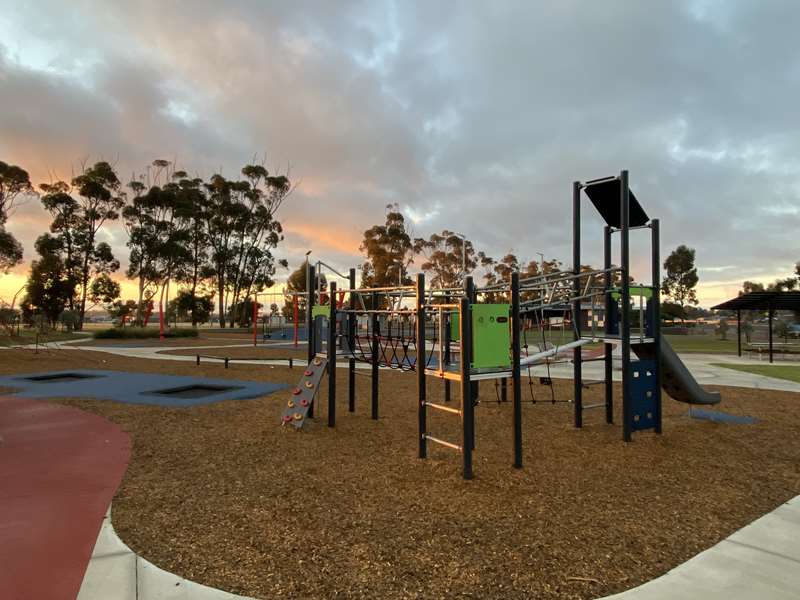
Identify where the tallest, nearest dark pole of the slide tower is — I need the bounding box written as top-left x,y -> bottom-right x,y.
619,171 -> 633,442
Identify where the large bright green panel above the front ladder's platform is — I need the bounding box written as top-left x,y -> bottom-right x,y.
471,304 -> 511,369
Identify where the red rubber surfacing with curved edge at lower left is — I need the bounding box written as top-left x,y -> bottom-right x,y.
0,396 -> 130,600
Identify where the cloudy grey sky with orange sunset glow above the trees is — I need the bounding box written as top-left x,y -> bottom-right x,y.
0,0 -> 800,305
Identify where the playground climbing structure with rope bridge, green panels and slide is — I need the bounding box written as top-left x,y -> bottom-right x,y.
282,171 -> 720,479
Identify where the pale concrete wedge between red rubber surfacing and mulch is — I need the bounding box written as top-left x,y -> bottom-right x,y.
77,508 -> 251,600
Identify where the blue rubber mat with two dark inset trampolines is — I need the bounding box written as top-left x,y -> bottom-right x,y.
0,369 -> 289,407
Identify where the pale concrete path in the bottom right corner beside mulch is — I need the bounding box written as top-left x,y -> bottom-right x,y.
608,496 -> 800,600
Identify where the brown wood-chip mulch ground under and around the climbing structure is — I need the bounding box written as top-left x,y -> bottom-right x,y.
0,351 -> 800,598
